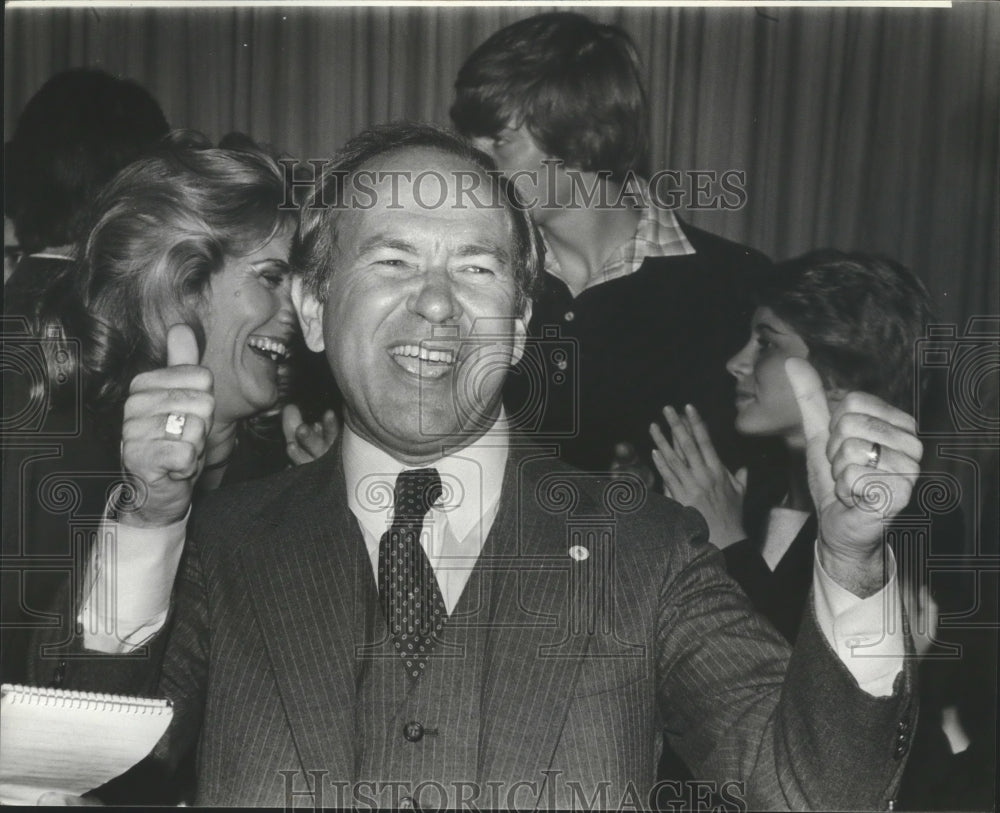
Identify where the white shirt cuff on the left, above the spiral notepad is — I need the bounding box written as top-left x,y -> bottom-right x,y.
77,508 -> 191,654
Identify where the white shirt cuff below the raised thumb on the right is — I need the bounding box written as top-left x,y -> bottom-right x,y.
813,548 -> 906,697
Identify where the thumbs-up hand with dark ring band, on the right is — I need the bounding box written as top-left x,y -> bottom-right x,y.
785,358 -> 923,598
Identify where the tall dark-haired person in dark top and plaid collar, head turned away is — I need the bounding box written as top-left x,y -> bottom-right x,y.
451,12 -> 767,477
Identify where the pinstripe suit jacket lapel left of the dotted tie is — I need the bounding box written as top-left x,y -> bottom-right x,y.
242,444 -> 371,779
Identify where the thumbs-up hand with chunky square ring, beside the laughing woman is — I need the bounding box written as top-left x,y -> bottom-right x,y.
119,325 -> 215,527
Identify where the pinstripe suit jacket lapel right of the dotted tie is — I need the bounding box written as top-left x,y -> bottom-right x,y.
479,449 -> 589,781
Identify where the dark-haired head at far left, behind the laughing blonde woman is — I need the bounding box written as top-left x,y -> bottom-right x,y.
4,68 -> 168,294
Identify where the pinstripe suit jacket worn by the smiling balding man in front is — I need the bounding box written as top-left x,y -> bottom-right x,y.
41,444 -> 916,809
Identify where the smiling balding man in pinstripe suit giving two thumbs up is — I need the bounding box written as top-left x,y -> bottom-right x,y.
36,124 -> 916,809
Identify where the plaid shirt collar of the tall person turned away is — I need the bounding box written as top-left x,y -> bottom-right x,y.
542,179 -> 695,290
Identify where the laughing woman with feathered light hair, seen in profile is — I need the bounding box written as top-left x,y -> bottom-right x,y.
3,134 -> 297,696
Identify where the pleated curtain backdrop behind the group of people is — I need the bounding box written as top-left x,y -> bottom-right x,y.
4,2 -> 1000,323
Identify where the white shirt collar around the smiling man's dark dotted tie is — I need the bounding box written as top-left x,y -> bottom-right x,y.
342,409 -> 510,541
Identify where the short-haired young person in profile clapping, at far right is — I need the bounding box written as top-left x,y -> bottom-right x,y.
650,251 -> 975,810
